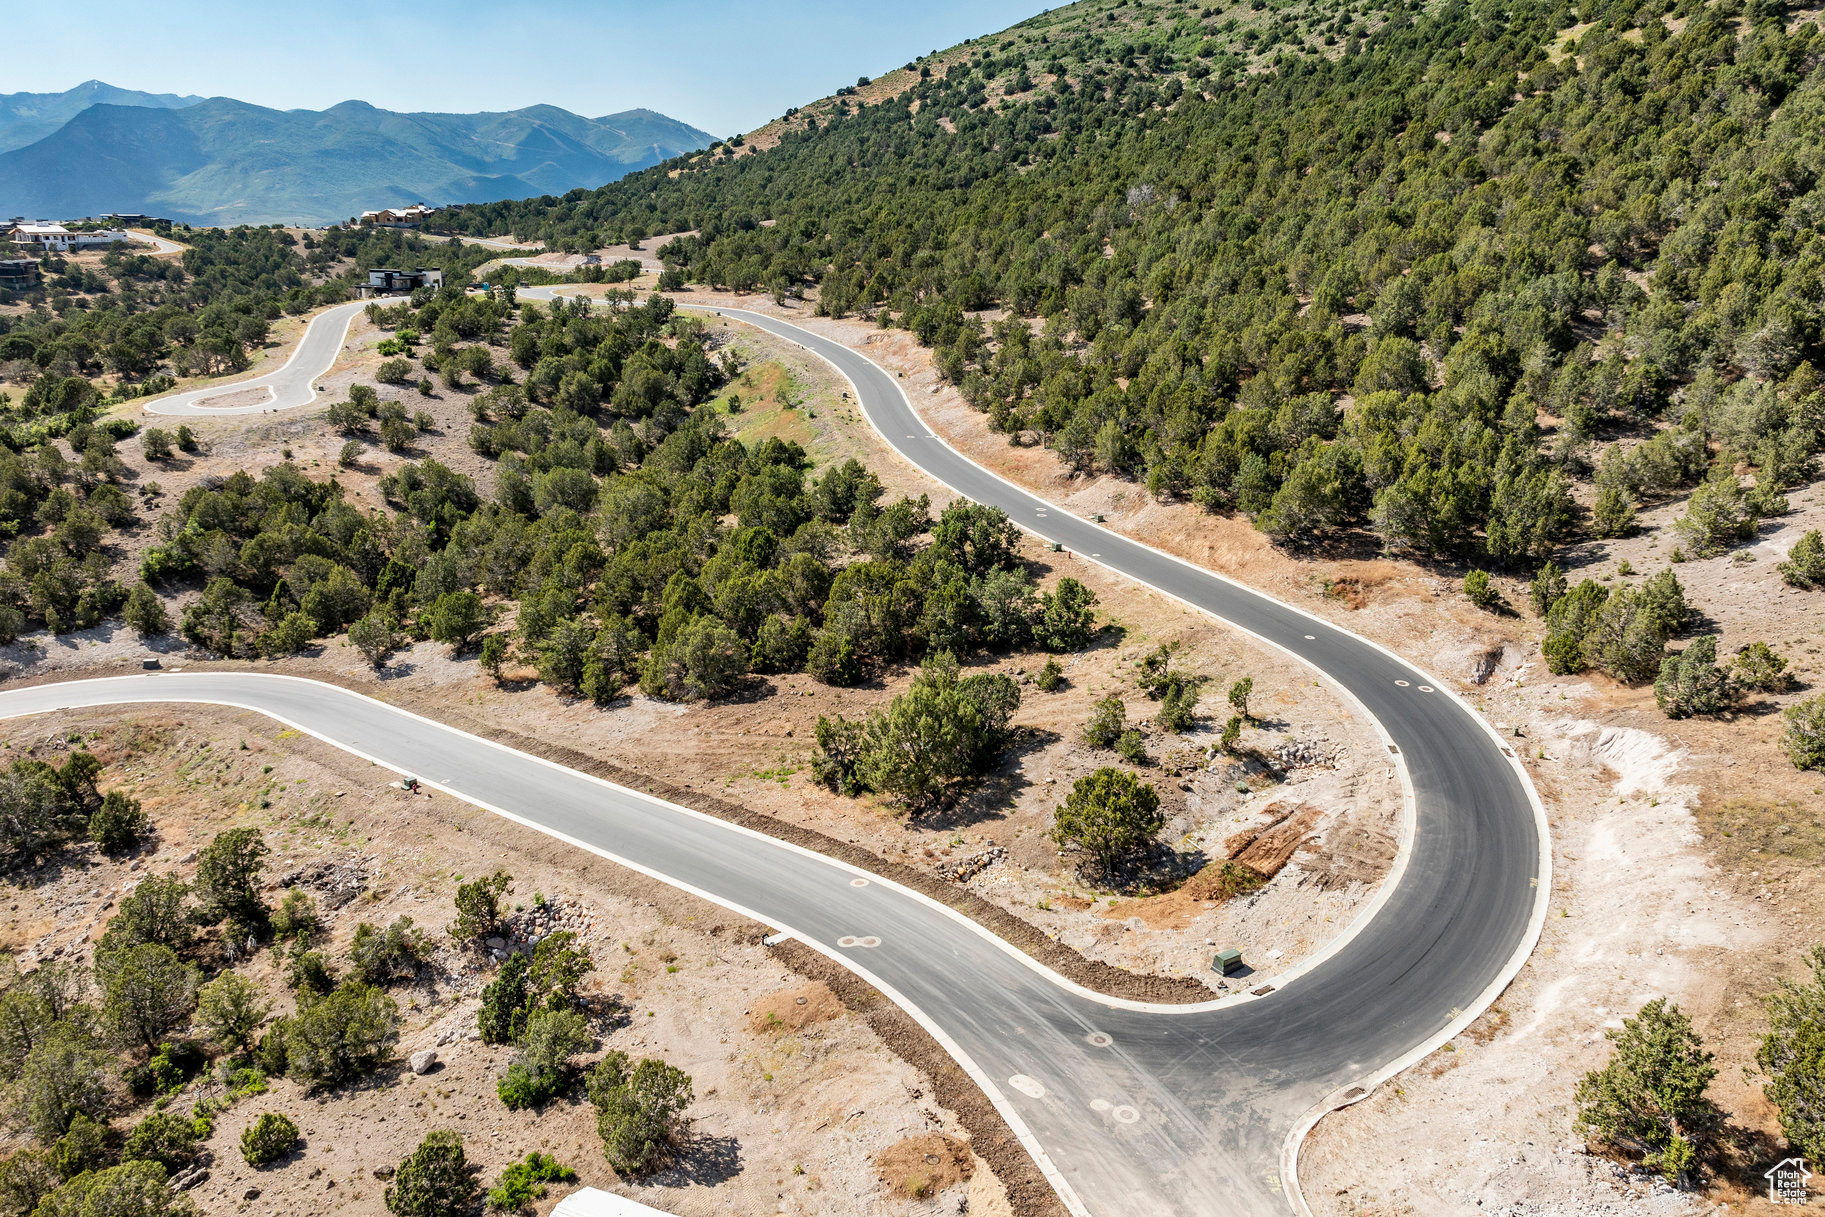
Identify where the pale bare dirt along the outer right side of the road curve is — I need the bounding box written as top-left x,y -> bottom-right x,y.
664,292 -> 1825,1215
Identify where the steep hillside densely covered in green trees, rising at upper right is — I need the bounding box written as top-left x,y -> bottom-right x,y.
441,0 -> 1825,564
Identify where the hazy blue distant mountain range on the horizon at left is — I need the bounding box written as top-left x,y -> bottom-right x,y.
0,80 -> 712,224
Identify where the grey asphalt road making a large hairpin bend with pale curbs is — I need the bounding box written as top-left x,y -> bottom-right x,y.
64,288 -> 1549,1217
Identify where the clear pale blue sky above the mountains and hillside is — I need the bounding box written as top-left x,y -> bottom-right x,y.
0,0 -> 1057,135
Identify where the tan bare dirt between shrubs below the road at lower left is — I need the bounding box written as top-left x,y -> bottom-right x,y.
0,708 -> 1007,1217
